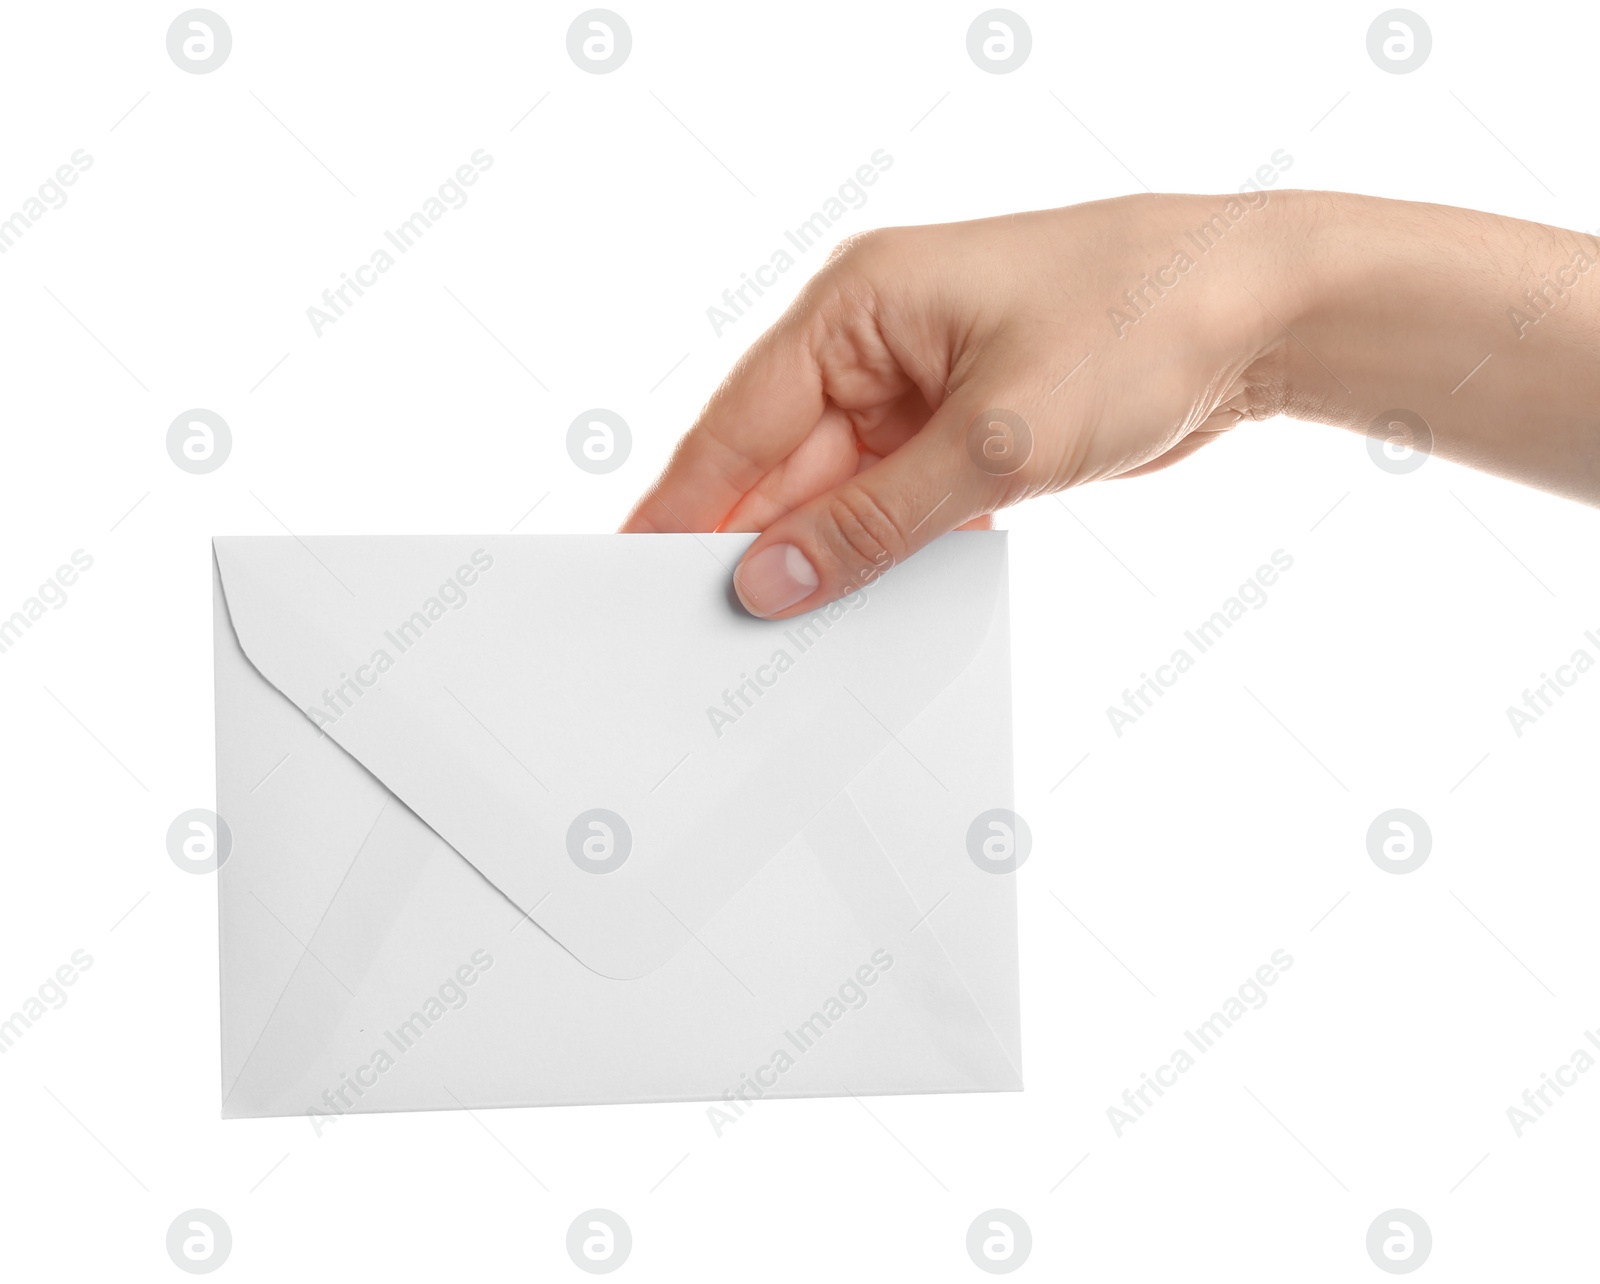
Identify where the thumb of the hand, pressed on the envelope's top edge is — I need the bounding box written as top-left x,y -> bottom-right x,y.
733,394 -> 1032,620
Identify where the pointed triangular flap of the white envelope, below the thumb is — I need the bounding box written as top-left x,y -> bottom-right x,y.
214,532 -> 1005,978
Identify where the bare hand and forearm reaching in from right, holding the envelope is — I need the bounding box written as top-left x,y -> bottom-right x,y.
622,192 -> 1600,620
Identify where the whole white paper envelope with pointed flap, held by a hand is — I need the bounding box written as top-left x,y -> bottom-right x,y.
213,532 -> 1022,1114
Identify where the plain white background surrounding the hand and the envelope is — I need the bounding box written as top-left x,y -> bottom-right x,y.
0,0 -> 1600,1281
